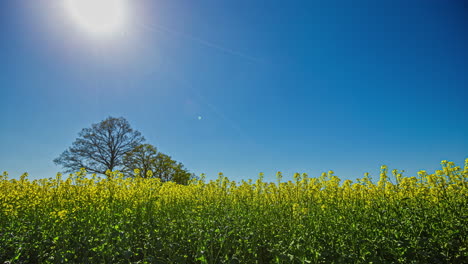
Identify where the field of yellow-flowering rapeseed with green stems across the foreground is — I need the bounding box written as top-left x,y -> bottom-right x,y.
0,160 -> 468,263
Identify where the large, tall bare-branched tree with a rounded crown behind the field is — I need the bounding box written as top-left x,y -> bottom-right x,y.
54,117 -> 145,174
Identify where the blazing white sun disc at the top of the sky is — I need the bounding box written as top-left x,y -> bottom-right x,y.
65,0 -> 128,36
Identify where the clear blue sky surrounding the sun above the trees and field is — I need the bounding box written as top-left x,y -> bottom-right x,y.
0,0 -> 468,180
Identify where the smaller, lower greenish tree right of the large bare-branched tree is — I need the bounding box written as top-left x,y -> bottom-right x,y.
123,144 -> 194,184
